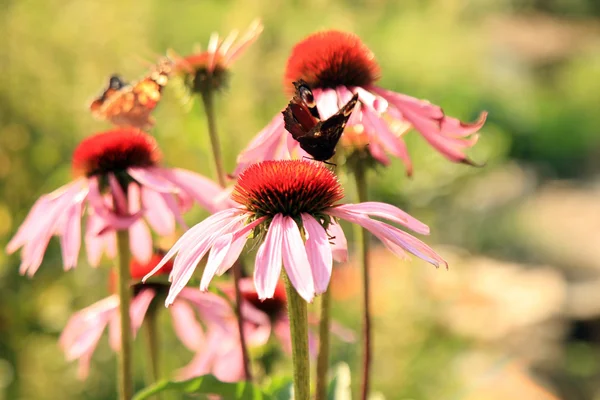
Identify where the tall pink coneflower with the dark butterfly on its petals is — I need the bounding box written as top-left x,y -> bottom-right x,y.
236,31 -> 487,175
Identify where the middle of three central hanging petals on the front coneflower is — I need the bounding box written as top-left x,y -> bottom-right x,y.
281,216 -> 316,303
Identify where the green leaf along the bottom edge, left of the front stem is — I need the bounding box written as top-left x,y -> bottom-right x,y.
133,375 -> 273,400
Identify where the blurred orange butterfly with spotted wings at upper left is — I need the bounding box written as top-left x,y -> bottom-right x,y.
90,58 -> 173,129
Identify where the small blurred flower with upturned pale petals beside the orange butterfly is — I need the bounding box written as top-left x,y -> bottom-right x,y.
170,20 -> 263,93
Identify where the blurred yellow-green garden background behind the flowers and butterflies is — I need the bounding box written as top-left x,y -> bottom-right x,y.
0,0 -> 600,400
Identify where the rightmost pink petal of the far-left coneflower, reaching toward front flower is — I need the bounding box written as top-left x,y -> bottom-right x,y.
155,168 -> 222,213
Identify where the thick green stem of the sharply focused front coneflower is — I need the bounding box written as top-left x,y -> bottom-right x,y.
283,273 -> 310,400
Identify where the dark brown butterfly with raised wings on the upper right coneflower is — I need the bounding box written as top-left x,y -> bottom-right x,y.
283,80 -> 358,162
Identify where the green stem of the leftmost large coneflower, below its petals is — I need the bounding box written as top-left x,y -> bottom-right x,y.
117,230 -> 133,400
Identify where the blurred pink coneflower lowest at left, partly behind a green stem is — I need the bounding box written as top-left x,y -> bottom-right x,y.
59,255 -> 239,380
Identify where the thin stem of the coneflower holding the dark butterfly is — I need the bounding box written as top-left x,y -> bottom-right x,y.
354,163 -> 373,400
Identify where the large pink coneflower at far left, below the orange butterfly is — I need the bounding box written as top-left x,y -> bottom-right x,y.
7,128 -> 221,276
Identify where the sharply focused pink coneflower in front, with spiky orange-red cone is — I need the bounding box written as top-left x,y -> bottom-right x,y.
144,160 -> 445,306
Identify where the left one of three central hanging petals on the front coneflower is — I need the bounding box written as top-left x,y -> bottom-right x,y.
254,214 -> 283,300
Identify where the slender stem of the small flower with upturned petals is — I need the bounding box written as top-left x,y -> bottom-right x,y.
201,89 -> 252,381
